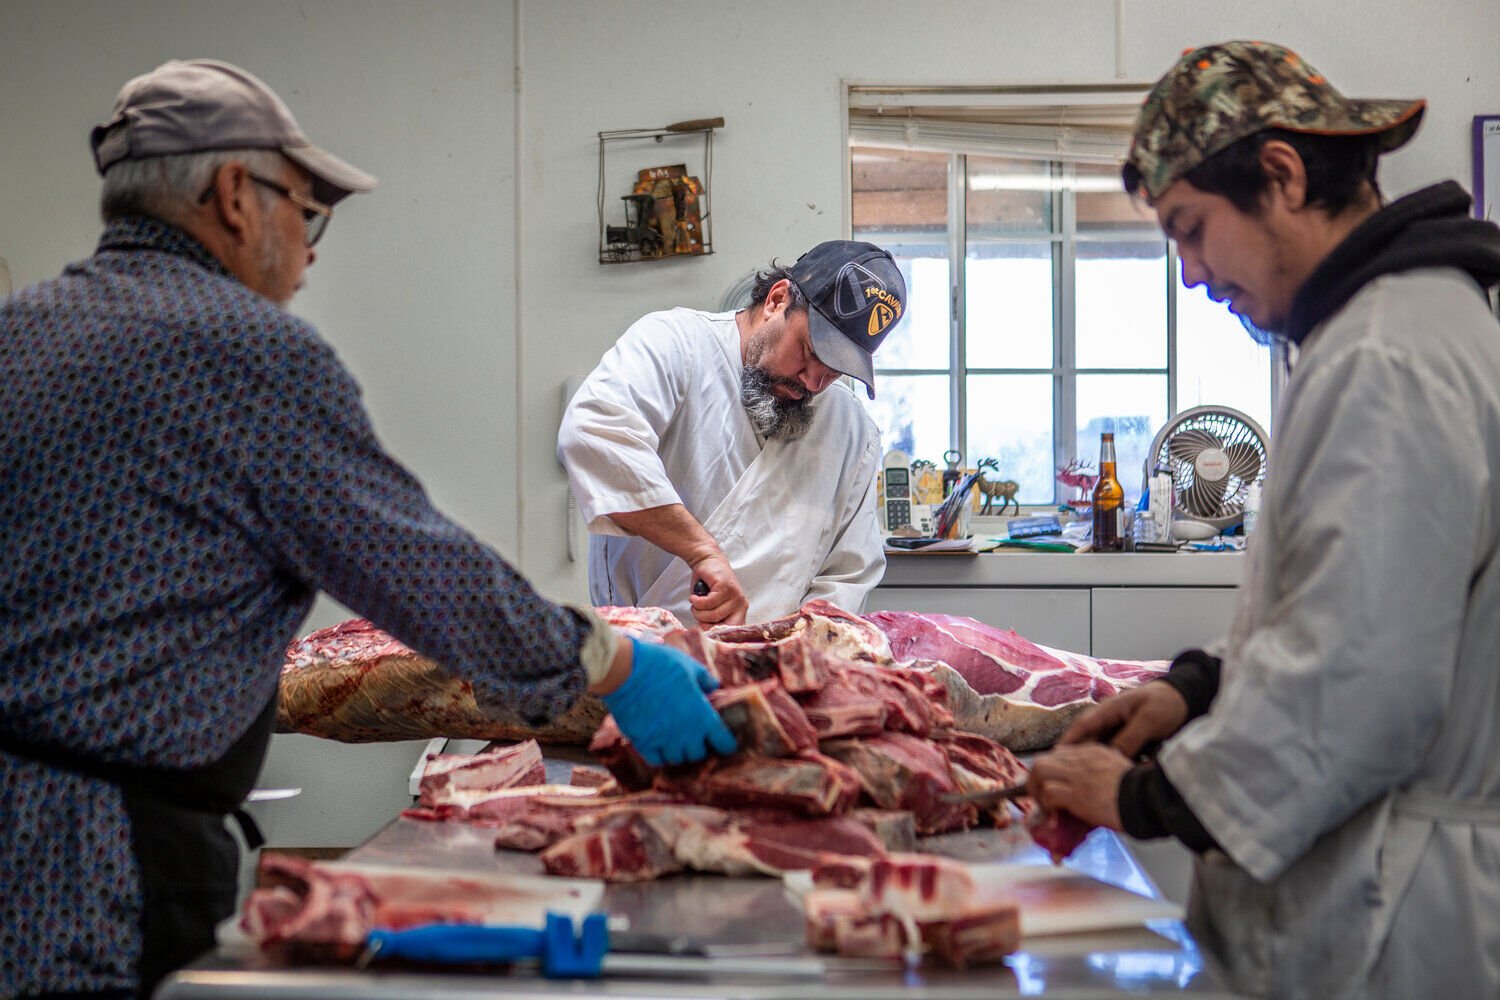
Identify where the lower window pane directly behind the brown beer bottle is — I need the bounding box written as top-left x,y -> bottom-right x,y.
1077,375 -> 1167,502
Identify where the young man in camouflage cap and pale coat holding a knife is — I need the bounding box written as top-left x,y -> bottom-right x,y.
1034,42 -> 1500,999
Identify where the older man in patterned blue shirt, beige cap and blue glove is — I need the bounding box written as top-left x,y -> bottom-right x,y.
0,60 -> 734,997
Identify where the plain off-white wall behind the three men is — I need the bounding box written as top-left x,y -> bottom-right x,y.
0,0 -> 1500,844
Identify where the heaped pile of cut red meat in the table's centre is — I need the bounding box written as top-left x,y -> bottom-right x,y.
410,604 -> 1092,882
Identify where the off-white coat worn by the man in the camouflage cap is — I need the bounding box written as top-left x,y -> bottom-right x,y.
1160,268 -> 1500,1000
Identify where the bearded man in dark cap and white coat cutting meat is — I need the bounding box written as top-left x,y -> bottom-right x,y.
558,240 -> 906,625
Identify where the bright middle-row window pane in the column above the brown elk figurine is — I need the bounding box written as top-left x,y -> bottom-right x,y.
963,241 -> 1053,370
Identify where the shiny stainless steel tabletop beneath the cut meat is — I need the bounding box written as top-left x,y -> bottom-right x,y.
156,762 -> 1233,1000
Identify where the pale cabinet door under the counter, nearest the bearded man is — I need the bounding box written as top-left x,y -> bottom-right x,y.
866,586 -> 1089,652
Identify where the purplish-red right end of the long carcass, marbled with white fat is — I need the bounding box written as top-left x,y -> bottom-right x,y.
867,612 -> 1170,751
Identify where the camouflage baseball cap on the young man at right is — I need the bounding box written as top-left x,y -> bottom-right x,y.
1125,42 -> 1427,201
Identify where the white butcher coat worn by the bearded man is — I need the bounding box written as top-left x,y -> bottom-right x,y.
558,309 -> 885,624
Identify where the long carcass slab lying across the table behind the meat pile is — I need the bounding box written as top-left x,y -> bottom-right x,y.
278,601 -> 1167,751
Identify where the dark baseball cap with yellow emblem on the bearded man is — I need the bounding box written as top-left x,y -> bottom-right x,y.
791,240 -> 906,399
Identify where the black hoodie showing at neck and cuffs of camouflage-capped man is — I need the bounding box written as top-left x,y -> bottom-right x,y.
1119,180 -> 1500,852
